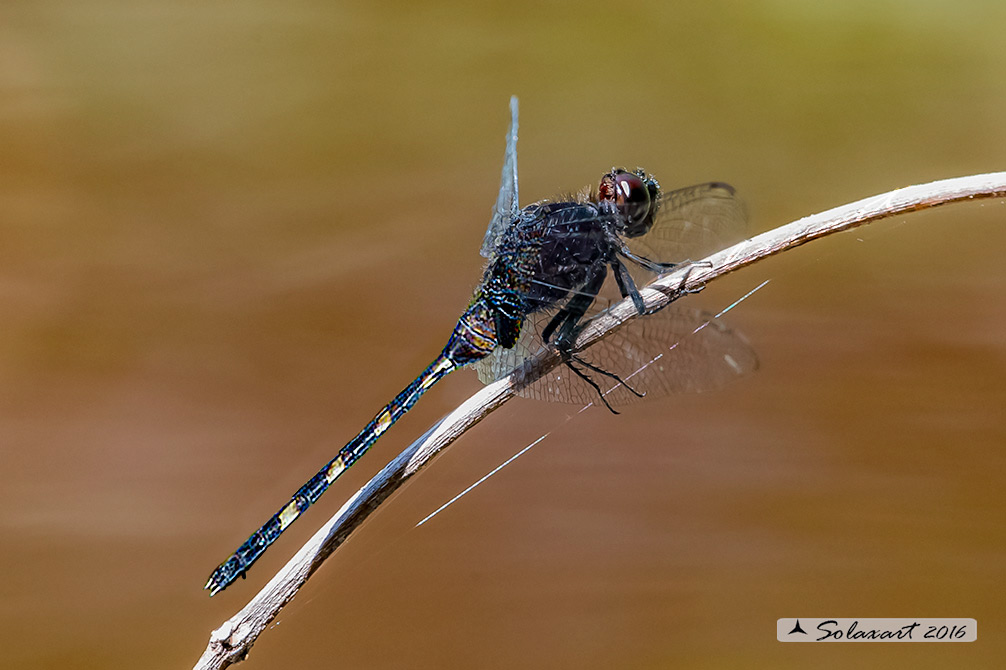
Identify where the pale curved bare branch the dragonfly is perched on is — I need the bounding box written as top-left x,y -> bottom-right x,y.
195,172 -> 1006,669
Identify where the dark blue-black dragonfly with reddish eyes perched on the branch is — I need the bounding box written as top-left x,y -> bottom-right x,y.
205,97 -> 758,596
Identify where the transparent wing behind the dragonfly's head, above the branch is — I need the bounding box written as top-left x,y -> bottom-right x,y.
626,181 -> 747,269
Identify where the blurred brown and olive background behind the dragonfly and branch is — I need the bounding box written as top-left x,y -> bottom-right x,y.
0,0 -> 1006,669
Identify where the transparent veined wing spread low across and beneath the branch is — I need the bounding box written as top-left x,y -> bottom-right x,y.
478,305 -> 758,406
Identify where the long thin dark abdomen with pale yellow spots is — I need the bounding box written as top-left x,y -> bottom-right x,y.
204,350 -> 459,596
